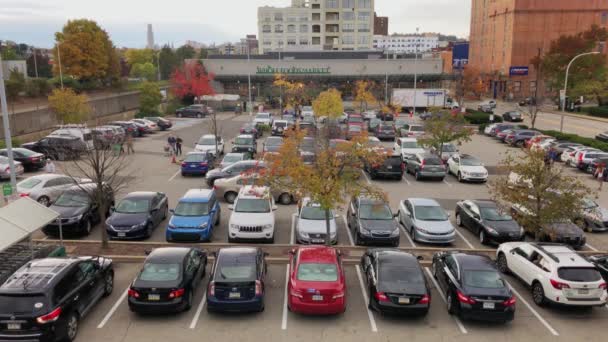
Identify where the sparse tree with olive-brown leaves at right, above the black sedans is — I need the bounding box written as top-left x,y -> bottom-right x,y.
490,150 -> 594,239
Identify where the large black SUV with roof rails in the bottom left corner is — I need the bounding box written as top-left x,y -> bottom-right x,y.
0,257 -> 114,342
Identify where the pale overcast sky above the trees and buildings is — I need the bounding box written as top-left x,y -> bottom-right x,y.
0,0 -> 471,47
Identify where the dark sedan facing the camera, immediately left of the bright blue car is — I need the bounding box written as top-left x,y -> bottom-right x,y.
106,191 -> 169,240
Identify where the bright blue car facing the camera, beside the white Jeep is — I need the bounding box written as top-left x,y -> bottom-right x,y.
166,189 -> 221,242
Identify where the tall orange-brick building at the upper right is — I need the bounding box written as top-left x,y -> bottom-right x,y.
469,0 -> 608,98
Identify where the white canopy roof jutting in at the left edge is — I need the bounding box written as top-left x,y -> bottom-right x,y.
0,197 -> 59,251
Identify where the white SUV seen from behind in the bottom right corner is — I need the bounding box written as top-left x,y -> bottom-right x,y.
496,242 -> 607,306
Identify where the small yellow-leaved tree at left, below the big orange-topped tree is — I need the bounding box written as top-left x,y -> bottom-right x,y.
48,88 -> 91,124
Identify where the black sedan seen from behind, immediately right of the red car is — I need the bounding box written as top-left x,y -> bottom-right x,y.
361,248 -> 431,316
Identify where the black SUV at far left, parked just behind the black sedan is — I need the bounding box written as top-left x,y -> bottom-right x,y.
21,136 -> 87,160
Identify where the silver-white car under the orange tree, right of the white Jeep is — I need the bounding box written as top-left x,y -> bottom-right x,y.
295,197 -> 338,245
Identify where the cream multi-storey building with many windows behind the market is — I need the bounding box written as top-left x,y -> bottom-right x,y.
258,0 -> 375,53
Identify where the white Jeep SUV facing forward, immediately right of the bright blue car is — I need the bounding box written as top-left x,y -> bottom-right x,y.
228,185 -> 277,243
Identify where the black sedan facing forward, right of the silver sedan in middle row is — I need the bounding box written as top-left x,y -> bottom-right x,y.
454,200 -> 525,245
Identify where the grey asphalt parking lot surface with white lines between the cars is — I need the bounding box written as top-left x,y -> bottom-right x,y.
14,114 -> 608,341
